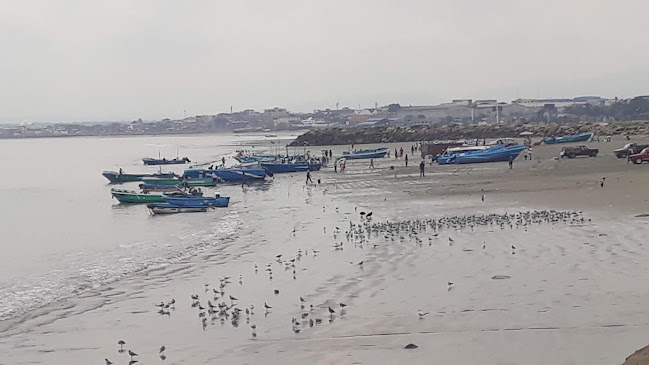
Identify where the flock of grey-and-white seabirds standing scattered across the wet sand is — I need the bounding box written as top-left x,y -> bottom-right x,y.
105,210 -> 590,365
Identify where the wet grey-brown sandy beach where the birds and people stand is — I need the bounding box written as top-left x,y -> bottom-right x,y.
0,135 -> 649,364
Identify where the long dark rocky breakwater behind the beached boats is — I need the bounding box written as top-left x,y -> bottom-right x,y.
291,122 -> 649,146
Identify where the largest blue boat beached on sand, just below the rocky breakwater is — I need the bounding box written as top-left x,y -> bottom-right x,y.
437,145 -> 525,165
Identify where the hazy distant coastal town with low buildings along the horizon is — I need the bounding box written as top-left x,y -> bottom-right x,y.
5,96 -> 649,139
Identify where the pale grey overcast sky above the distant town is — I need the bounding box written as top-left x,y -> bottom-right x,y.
0,0 -> 649,122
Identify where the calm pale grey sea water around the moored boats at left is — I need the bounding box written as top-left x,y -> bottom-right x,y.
0,135 -> 298,319
